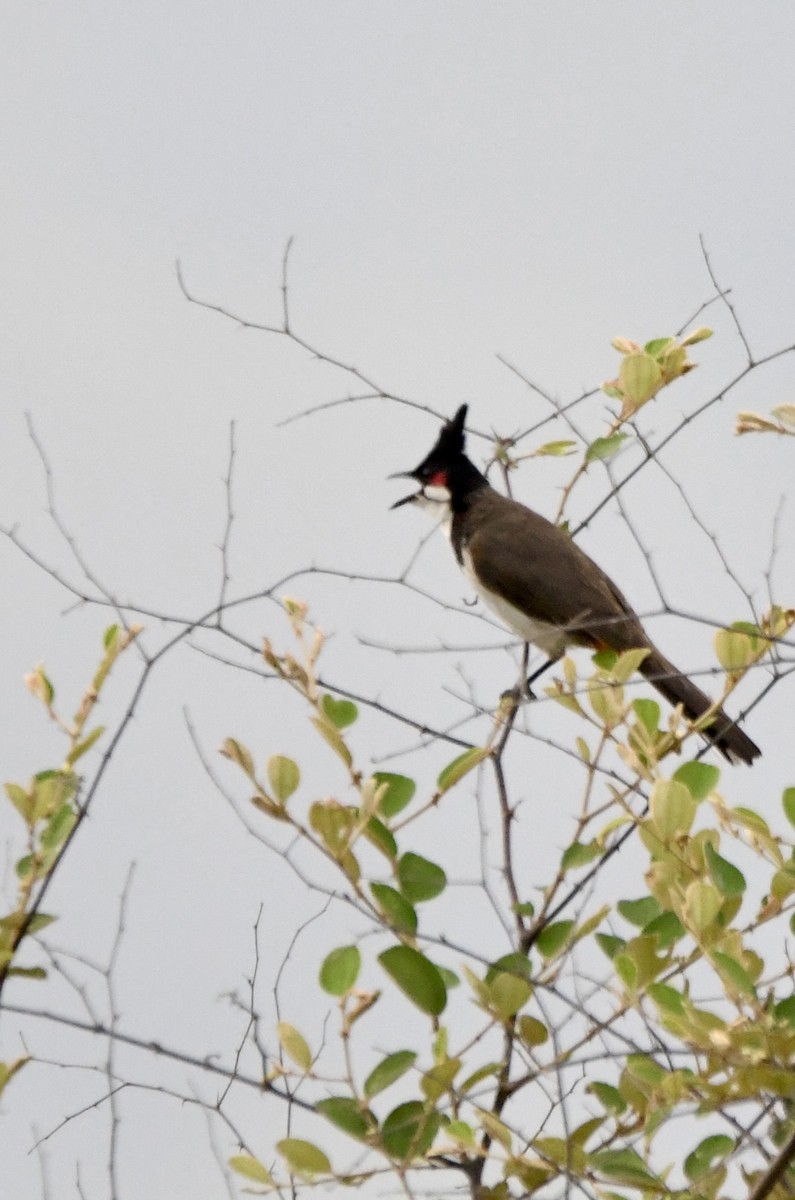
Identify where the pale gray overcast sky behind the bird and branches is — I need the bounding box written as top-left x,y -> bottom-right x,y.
0,0 -> 795,1200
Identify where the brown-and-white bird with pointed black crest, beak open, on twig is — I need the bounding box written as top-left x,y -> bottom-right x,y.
390,404 -> 761,764
